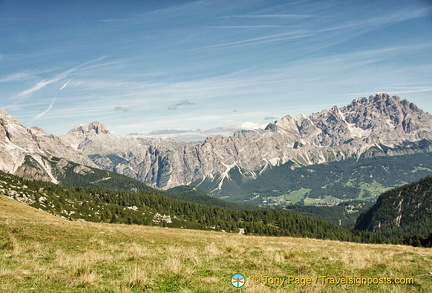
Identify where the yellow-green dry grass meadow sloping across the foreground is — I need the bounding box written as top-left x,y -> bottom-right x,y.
0,195 -> 432,293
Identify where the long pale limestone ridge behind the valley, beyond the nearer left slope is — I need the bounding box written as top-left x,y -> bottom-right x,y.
62,93 -> 432,188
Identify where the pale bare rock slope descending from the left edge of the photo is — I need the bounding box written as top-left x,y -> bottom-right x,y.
0,109 -> 95,183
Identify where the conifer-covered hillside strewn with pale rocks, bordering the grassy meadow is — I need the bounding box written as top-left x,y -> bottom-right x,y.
0,173 -> 360,241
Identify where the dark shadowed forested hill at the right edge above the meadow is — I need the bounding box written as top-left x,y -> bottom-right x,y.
355,176 -> 432,237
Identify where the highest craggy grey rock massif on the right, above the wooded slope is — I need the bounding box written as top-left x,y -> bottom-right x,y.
258,93 -> 432,147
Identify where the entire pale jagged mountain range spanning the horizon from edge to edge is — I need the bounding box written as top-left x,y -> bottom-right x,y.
0,93 -> 432,204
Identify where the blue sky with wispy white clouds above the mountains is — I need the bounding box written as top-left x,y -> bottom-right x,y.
0,0 -> 432,139
